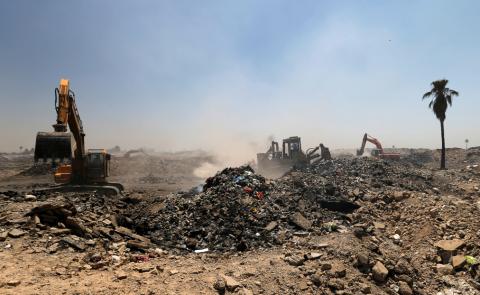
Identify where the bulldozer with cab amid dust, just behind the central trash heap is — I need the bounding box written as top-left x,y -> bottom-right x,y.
257,136 -> 320,174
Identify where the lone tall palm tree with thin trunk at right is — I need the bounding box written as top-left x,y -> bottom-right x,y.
422,79 -> 458,169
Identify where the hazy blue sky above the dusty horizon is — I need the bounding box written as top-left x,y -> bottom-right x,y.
0,0 -> 480,163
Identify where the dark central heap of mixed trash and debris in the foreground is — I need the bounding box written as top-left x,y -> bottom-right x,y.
126,166 -> 358,252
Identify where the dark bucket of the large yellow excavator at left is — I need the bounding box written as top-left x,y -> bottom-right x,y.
34,132 -> 74,162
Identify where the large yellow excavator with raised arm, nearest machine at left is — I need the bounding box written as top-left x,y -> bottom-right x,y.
34,79 -> 123,194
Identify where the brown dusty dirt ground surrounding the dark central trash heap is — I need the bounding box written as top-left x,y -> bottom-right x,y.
0,149 -> 480,295
